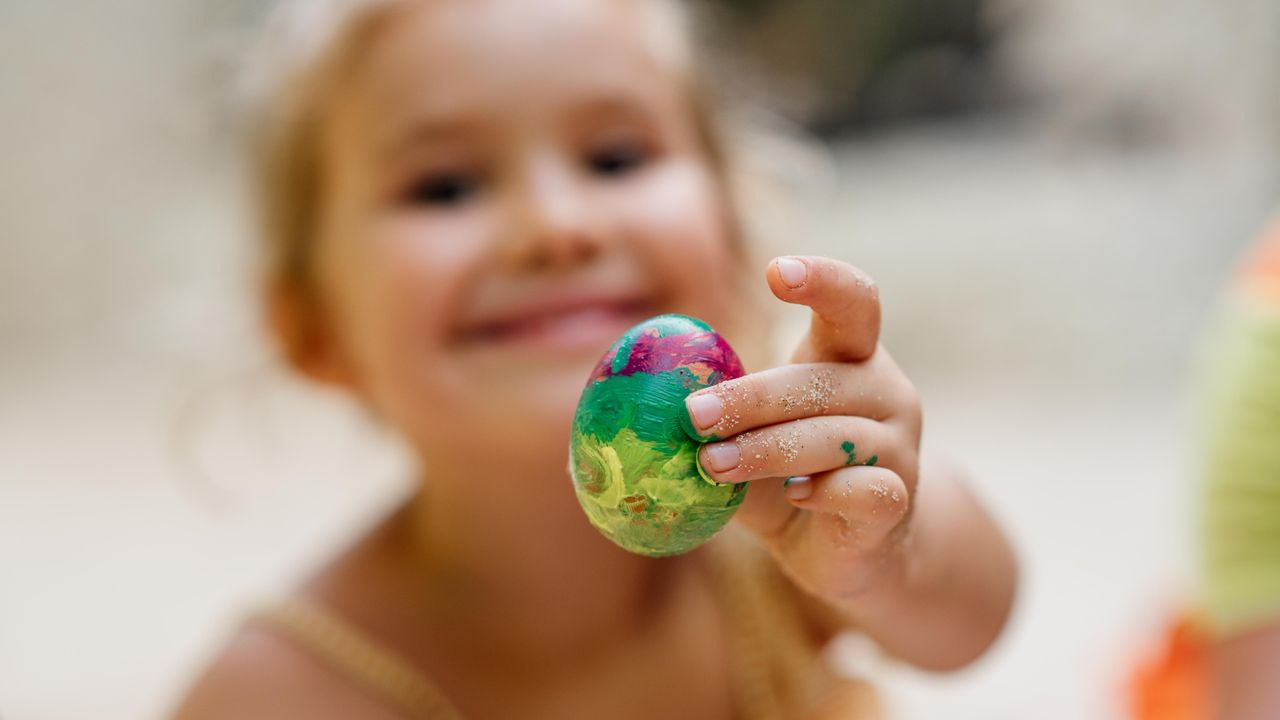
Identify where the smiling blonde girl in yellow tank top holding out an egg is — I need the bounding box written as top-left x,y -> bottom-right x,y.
178,0 -> 1015,719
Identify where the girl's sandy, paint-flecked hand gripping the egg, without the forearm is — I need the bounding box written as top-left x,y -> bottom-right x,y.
686,256 -> 920,605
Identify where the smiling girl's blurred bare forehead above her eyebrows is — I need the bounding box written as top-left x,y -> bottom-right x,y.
356,0 -> 682,132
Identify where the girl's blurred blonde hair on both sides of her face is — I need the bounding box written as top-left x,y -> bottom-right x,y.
246,0 -> 768,366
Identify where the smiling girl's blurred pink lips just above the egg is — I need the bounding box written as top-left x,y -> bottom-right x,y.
460,300 -> 654,351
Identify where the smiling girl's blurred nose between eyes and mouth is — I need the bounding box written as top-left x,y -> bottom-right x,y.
504,158 -> 603,270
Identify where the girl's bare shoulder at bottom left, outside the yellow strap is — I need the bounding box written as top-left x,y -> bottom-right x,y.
174,624 -> 393,720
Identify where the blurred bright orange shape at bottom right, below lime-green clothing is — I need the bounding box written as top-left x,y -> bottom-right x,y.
1129,609 -> 1211,720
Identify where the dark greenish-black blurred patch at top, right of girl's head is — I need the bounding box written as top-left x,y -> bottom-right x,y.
713,0 -> 1004,135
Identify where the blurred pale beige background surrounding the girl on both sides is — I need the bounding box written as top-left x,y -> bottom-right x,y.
0,0 -> 1280,719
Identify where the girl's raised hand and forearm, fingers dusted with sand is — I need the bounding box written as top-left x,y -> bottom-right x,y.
686,258 -> 1016,670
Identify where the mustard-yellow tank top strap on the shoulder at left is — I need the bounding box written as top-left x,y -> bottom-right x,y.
248,598 -> 462,720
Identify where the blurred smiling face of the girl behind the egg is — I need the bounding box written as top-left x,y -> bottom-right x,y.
303,0 -> 733,455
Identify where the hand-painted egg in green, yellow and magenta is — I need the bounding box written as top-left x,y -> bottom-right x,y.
570,315 -> 746,556
